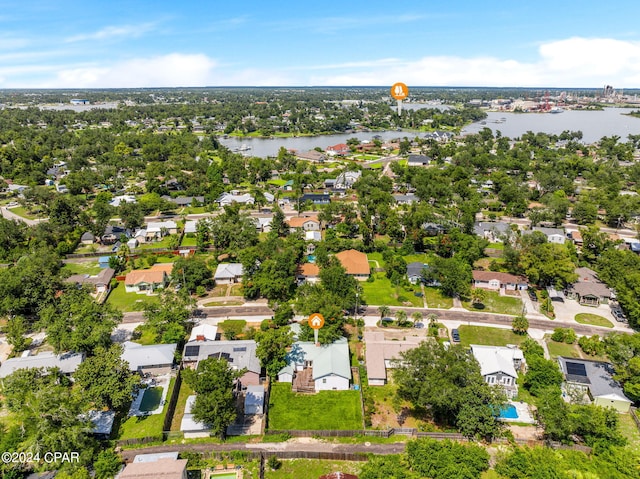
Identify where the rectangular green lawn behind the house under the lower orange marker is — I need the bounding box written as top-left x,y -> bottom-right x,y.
269,383 -> 362,430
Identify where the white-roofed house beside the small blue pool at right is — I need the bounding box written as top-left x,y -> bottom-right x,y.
471,344 -> 525,399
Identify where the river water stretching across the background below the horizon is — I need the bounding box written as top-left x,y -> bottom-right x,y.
220,104 -> 640,158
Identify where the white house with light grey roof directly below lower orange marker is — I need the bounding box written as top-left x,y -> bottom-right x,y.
278,338 -> 351,392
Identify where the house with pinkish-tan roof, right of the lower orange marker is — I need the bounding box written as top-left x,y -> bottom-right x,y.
364,331 -> 425,386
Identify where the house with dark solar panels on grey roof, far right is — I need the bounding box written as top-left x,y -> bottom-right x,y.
557,356 -> 632,413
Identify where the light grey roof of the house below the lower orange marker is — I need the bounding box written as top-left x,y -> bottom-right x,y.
280,338 -> 351,380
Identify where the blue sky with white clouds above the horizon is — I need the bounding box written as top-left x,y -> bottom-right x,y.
0,0 -> 640,88
